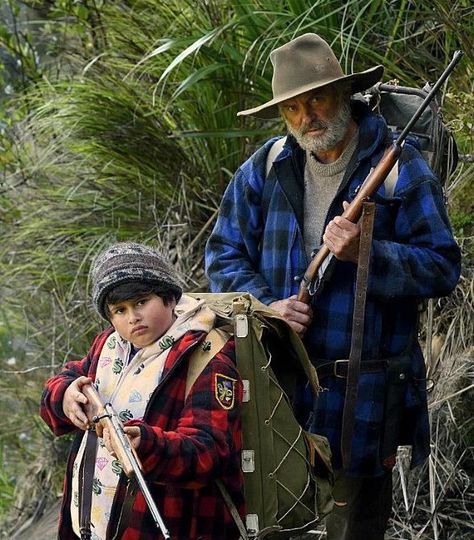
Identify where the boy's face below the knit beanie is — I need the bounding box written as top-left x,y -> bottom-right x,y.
107,293 -> 176,349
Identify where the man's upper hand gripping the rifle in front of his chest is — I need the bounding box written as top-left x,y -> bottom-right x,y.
323,201 -> 360,264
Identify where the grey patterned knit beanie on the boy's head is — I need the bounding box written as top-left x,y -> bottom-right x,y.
90,242 -> 183,320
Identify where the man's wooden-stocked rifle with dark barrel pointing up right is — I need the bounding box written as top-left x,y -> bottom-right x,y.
298,51 -> 463,304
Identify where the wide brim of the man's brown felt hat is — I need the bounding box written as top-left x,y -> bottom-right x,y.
237,66 -> 384,120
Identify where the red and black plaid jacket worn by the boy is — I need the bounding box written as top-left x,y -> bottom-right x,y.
40,329 -> 244,540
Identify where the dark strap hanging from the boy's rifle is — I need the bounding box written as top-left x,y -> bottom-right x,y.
79,429 -> 97,540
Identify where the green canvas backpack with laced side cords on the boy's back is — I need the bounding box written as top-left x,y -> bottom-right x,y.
187,293 -> 333,540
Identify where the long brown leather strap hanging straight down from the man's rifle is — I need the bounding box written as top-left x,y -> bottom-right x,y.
341,201 -> 375,470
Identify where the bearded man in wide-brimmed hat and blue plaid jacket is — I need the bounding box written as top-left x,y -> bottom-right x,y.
206,34 -> 460,540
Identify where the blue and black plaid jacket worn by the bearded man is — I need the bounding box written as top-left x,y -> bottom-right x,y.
206,103 -> 460,476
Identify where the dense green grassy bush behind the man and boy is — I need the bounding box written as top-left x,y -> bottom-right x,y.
0,0 -> 474,538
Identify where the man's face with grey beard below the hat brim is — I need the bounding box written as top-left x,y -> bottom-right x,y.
279,85 -> 351,153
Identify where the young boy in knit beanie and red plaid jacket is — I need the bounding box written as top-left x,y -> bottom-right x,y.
41,243 -> 243,540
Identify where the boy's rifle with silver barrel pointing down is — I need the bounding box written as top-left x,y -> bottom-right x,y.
82,384 -> 171,540
